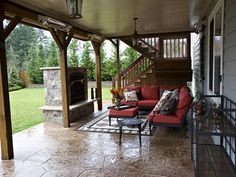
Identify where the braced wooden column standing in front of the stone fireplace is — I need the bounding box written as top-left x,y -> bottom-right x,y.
49,28 -> 72,128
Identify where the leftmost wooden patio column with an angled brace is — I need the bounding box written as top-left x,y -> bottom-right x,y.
0,0 -> 21,160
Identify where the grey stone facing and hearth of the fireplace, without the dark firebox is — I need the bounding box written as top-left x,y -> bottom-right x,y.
40,67 -> 96,125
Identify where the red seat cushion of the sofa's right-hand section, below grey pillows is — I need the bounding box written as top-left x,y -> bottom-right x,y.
147,111 -> 181,125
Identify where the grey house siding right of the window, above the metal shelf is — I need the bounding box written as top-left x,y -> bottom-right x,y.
223,0 -> 236,102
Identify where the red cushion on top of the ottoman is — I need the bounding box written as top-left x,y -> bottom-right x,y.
109,107 -> 139,117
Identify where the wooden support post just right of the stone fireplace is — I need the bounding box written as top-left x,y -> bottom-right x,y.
91,41 -> 102,110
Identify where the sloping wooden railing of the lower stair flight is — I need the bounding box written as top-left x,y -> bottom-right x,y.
112,55 -> 153,88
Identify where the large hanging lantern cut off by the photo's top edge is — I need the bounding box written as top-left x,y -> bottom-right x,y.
66,0 -> 83,19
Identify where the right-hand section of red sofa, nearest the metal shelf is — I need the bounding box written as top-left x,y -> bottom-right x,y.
147,87 -> 193,133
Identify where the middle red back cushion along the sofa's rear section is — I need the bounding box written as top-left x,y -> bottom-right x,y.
141,85 -> 160,100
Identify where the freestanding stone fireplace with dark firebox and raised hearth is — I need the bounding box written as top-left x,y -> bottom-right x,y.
40,67 -> 96,125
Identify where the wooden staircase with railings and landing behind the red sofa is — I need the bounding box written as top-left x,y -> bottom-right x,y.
113,32 -> 192,87
